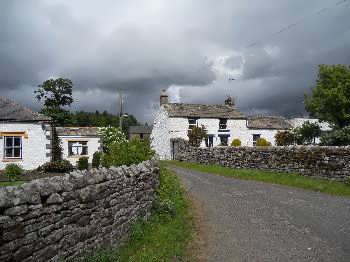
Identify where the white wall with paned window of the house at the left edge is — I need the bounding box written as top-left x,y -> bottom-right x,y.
0,122 -> 50,170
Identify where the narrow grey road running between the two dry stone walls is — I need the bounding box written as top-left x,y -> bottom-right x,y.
169,166 -> 350,262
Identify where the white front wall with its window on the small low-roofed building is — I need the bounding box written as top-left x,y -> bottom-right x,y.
59,136 -> 100,165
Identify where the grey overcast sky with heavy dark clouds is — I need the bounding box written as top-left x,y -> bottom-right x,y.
0,0 -> 350,122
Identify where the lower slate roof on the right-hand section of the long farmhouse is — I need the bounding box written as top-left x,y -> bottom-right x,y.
247,116 -> 293,130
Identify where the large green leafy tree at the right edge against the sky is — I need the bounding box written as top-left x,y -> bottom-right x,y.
305,65 -> 350,128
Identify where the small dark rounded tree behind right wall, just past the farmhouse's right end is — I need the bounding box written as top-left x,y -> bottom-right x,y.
293,121 -> 321,145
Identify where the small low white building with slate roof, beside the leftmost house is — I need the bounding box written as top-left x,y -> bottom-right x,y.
56,127 -> 102,165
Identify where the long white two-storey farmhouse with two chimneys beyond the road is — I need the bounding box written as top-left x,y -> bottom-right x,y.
151,90 -> 328,159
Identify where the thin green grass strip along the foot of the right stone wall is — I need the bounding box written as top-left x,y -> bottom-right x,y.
164,161 -> 350,196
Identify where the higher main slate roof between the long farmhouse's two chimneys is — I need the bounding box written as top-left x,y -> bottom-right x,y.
163,103 -> 246,119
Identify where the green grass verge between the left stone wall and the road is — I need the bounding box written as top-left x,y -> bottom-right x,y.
83,167 -> 193,262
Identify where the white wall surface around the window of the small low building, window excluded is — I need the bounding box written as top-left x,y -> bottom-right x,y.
59,136 -> 100,165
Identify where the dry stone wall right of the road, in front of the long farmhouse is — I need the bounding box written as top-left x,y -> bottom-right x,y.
173,139 -> 350,181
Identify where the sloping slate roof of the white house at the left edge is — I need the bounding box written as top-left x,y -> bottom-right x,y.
0,96 -> 50,121
